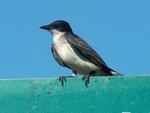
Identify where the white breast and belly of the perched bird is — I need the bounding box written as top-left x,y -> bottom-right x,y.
54,31 -> 99,75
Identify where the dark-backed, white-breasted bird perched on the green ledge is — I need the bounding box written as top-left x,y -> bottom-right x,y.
40,20 -> 121,87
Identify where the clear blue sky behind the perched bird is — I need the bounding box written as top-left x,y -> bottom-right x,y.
0,0 -> 150,78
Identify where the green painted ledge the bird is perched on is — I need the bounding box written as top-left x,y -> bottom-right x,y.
0,76 -> 150,113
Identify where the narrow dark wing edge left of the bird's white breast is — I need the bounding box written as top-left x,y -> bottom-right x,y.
51,44 -> 69,68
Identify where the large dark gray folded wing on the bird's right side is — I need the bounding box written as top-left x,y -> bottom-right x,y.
65,33 -> 111,75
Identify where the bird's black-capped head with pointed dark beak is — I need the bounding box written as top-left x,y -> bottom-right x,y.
40,20 -> 72,35
